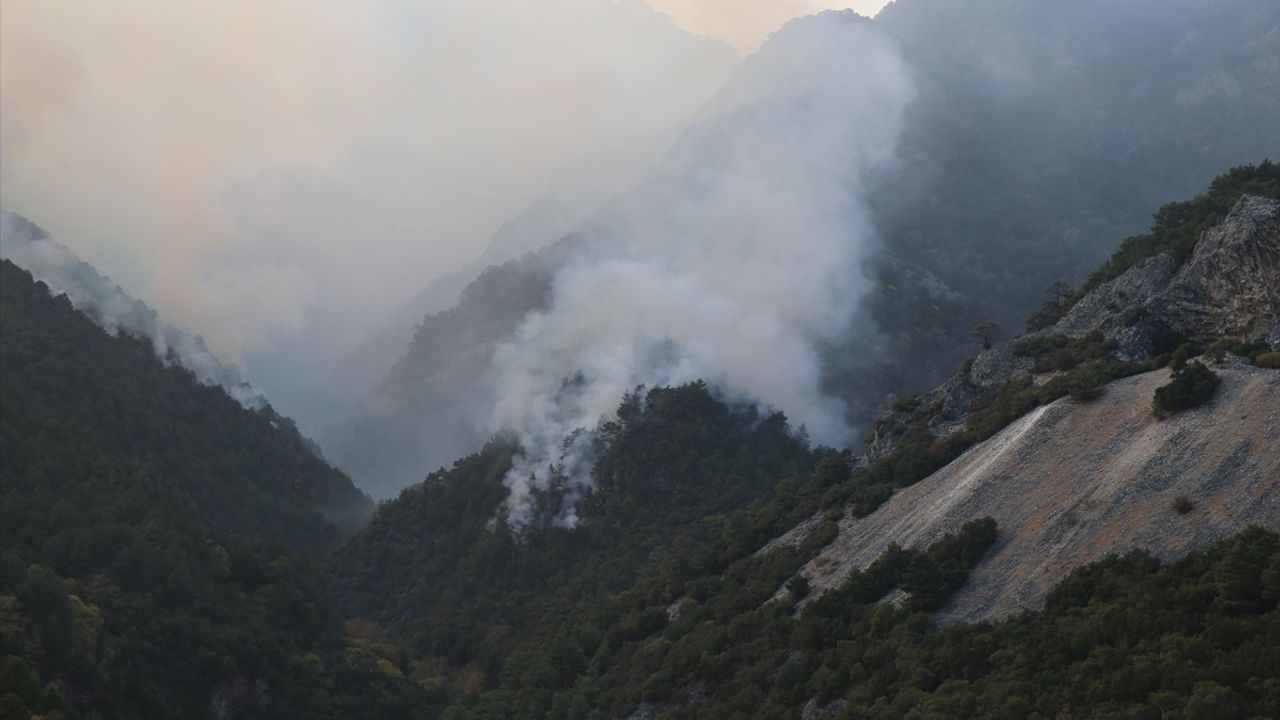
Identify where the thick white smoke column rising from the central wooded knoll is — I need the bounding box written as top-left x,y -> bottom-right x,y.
483,13 -> 913,528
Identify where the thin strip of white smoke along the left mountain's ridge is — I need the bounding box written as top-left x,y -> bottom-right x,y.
0,210 -> 266,410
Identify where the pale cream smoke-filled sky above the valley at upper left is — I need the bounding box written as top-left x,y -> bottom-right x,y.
0,0 -> 882,368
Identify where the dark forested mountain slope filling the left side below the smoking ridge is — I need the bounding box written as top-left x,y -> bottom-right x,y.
0,259 -> 430,719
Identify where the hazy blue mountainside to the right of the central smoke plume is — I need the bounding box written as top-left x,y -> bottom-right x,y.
829,0 -> 1280,399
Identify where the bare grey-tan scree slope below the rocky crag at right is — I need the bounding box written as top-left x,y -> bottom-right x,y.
803,360 -> 1280,623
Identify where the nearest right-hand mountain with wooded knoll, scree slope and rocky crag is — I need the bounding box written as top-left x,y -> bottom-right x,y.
328,170 -> 1280,720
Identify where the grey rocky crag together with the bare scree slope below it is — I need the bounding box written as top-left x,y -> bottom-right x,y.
771,195 -> 1280,621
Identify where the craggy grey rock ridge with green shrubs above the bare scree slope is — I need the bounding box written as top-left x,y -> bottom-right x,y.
860,176 -> 1280,465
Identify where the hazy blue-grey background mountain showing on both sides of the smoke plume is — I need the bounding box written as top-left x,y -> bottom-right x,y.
325,0 -> 1280,495
